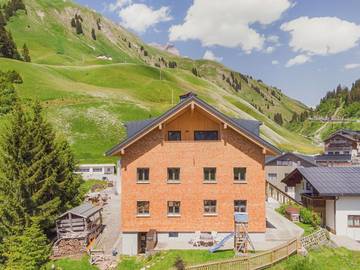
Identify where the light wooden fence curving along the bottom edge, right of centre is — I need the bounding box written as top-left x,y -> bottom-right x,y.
185,239 -> 299,270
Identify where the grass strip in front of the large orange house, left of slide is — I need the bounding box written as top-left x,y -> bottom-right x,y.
117,250 -> 234,270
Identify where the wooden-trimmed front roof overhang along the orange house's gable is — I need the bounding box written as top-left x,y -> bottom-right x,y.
105,96 -> 281,156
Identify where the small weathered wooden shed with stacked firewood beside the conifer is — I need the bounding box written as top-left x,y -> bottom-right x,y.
53,203 -> 103,256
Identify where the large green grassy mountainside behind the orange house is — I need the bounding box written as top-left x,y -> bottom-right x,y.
0,0 -> 319,162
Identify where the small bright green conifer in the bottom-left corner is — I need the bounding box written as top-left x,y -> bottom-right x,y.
3,222 -> 50,270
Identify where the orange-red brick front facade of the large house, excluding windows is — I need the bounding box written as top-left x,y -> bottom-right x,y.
116,106 -> 265,232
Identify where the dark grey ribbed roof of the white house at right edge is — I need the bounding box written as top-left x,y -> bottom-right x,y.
282,167 -> 360,196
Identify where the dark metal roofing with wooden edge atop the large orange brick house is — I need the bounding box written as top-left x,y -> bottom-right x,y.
106,94 -> 281,156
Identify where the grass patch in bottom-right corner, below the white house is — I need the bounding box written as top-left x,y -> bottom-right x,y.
270,247 -> 360,270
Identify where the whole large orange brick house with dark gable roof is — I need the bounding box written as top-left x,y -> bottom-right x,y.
107,93 -> 280,255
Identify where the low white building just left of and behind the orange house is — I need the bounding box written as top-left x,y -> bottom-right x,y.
75,164 -> 116,181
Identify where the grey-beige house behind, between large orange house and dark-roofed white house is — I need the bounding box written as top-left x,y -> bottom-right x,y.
265,152 -> 317,198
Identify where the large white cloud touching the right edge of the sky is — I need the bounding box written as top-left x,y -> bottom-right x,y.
280,17 -> 360,55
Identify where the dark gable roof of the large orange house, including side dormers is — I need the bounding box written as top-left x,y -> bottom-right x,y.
106,93 -> 281,156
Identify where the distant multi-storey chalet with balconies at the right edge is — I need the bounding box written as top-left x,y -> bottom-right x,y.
315,129 -> 360,167
